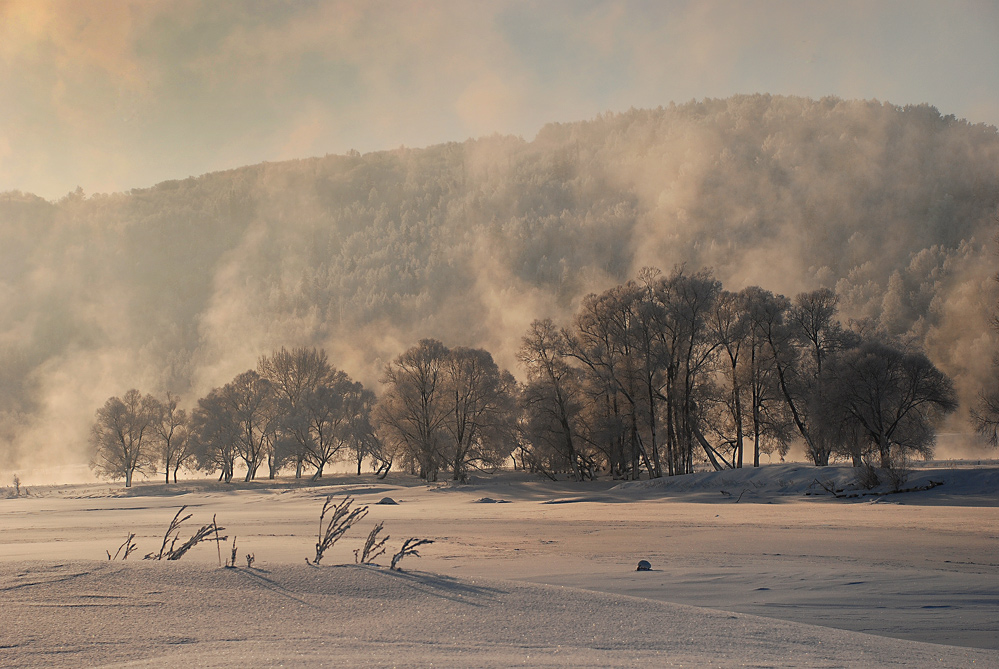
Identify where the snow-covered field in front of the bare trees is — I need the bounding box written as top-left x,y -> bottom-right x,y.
0,462 -> 999,667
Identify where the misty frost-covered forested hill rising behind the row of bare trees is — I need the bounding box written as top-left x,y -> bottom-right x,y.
0,95 -> 999,464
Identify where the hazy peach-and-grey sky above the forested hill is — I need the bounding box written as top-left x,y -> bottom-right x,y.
0,0 -> 999,199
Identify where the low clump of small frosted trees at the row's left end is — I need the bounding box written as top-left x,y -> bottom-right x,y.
90,348 -> 379,486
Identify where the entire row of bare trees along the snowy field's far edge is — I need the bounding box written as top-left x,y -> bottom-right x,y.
91,268 -> 957,485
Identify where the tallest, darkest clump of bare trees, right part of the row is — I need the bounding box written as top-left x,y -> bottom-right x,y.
520,268 -> 957,480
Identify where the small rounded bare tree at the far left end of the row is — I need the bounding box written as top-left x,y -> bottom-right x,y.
90,388 -> 156,487
